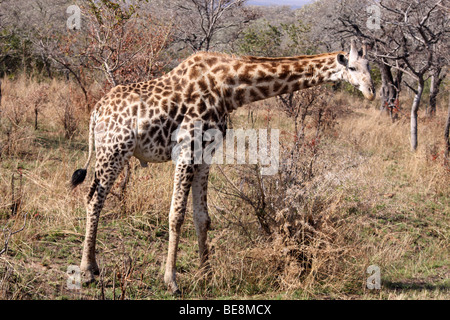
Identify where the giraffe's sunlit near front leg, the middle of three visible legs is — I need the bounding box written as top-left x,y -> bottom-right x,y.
164,161 -> 193,294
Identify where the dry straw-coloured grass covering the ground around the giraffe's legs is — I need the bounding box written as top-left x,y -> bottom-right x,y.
0,78 -> 450,299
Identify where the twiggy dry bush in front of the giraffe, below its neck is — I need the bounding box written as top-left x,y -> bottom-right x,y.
211,88 -> 365,290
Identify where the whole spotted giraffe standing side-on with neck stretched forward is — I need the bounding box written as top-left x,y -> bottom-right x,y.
71,41 -> 375,294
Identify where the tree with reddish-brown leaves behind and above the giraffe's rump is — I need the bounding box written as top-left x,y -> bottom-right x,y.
34,0 -> 171,110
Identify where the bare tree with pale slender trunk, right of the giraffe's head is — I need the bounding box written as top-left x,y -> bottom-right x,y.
328,0 -> 450,151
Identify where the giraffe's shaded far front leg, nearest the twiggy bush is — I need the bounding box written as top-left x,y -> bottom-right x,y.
192,164 -> 211,272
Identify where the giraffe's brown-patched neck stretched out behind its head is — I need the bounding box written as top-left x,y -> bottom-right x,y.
223,52 -> 345,109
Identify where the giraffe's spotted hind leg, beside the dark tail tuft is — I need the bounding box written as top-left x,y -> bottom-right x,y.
80,147 -> 133,283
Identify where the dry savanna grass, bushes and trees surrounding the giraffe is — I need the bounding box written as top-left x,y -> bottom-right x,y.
0,0 -> 450,299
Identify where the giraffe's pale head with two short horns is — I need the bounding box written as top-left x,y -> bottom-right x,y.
337,40 -> 375,101
